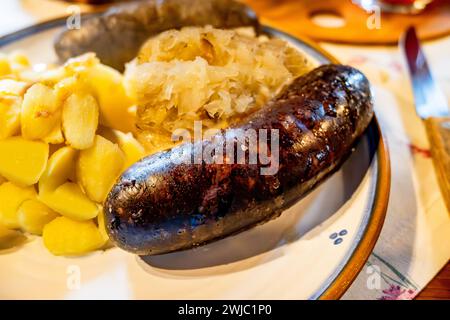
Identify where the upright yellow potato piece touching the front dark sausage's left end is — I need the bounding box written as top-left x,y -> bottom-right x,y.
77,135 -> 125,203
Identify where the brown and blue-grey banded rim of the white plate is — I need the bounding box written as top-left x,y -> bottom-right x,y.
0,16 -> 391,300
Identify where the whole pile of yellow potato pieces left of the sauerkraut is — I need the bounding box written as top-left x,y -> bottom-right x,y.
0,53 -> 145,255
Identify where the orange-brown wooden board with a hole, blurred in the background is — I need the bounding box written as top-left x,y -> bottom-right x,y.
243,0 -> 450,44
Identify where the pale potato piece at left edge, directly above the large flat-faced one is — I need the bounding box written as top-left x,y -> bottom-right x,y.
0,96 -> 22,140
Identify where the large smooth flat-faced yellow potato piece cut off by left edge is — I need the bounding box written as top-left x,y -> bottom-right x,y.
0,137 -> 49,186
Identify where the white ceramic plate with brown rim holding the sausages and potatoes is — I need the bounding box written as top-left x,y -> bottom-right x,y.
0,19 -> 389,299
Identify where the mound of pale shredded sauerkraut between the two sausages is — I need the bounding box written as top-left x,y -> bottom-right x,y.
125,27 -> 312,149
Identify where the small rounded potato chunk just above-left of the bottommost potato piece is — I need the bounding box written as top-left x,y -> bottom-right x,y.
17,200 -> 58,235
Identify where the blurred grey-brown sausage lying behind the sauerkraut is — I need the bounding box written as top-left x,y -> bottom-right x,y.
54,0 -> 259,71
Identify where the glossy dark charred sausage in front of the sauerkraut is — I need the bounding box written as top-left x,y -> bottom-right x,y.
104,65 -> 373,255
